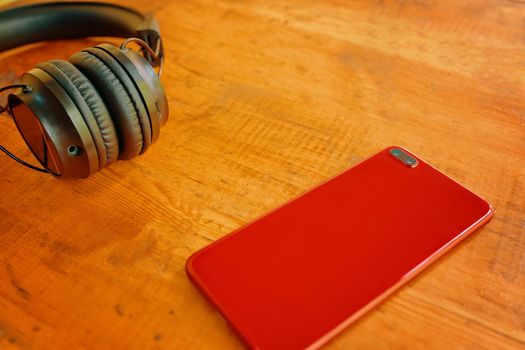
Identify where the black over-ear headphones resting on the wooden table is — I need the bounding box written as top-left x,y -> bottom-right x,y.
0,2 -> 168,177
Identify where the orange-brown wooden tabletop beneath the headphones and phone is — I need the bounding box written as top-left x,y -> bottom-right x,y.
0,0 -> 525,349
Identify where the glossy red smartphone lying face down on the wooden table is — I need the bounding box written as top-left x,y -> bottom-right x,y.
186,147 -> 492,349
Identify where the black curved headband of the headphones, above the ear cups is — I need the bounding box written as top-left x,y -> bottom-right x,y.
0,2 -> 163,66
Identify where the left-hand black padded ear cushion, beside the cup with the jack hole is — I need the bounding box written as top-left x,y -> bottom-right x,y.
36,60 -> 118,169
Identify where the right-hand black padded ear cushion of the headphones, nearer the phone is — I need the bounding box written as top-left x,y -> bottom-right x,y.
69,48 -> 151,159
